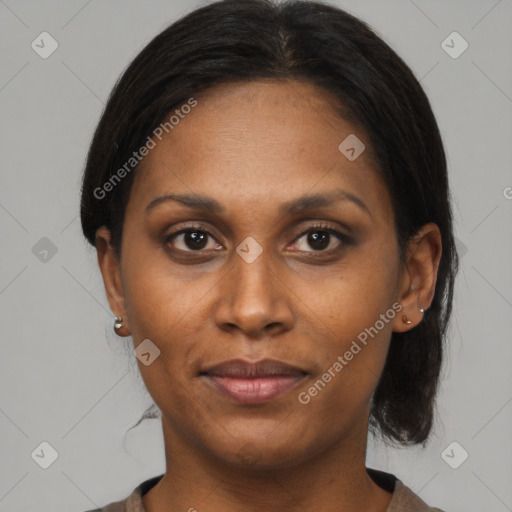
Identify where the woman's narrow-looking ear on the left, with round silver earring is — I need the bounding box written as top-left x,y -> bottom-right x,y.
95,226 -> 130,336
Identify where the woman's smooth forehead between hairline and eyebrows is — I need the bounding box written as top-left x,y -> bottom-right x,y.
132,81 -> 389,218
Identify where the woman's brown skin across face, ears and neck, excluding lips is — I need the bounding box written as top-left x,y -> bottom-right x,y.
96,81 -> 441,512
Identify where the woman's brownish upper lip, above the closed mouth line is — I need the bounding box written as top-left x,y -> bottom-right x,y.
200,359 -> 308,379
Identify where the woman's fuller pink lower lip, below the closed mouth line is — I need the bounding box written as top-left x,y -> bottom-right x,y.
202,375 -> 303,404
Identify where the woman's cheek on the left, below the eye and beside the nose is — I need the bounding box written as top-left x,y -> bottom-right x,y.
120,251 -> 218,376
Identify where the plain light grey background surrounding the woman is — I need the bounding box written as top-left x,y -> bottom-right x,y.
0,0 -> 512,512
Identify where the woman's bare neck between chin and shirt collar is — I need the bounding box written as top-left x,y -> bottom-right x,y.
143,420 -> 392,512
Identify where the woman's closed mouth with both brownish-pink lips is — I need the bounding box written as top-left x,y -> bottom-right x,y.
199,359 -> 309,404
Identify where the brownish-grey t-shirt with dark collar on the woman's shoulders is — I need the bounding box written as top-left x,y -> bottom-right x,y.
83,468 -> 444,512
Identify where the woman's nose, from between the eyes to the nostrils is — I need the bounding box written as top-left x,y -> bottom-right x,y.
215,246 -> 294,339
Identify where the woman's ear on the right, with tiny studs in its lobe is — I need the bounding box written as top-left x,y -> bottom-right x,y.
393,222 -> 442,332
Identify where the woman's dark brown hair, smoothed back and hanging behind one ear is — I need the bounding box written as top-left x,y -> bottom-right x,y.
81,0 -> 458,444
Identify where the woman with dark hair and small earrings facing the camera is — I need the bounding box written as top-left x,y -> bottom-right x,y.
81,0 -> 457,512
